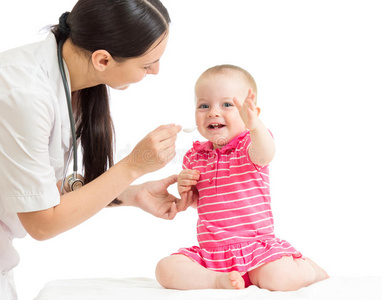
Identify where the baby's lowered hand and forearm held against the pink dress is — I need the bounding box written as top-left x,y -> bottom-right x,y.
178,169 -> 200,208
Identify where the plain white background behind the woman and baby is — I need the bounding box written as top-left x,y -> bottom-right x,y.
0,0 -> 382,300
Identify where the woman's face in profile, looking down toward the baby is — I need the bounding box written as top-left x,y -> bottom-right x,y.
103,32 -> 168,90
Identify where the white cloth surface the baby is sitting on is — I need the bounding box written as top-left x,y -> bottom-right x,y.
35,276 -> 382,300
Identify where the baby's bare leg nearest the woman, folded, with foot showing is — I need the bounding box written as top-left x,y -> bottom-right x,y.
155,254 -> 244,290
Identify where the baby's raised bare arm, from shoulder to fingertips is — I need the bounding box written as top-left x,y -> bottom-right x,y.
233,89 -> 275,166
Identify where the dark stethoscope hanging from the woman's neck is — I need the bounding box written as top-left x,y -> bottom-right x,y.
57,41 -> 84,194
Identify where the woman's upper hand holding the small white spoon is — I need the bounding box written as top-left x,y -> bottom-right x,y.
121,124 -> 182,177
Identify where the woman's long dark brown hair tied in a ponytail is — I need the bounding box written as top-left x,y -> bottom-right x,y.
51,0 -> 170,204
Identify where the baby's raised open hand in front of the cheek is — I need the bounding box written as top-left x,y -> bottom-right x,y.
233,89 -> 260,130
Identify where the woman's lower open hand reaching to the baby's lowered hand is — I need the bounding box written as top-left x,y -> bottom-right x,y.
132,175 -> 192,220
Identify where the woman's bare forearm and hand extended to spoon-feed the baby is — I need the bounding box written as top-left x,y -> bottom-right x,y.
18,125 -> 181,240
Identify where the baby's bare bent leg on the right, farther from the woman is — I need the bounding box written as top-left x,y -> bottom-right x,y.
249,256 -> 329,291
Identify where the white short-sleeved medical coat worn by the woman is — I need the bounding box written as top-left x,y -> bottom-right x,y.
0,33 -> 70,299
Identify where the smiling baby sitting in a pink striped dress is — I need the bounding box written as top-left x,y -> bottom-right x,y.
156,65 -> 328,291
